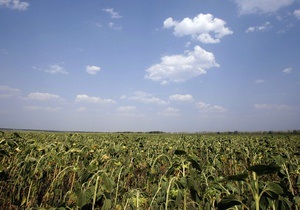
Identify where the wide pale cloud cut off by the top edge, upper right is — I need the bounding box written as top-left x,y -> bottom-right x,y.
234,0 -> 295,15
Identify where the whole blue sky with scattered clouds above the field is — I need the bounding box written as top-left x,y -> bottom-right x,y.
0,0 -> 300,132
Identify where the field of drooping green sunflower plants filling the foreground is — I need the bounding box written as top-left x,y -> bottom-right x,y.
0,131 -> 300,210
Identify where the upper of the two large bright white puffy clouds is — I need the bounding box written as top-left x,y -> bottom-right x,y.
164,13 -> 233,43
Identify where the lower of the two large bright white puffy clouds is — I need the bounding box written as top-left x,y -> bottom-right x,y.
145,46 -> 219,84
